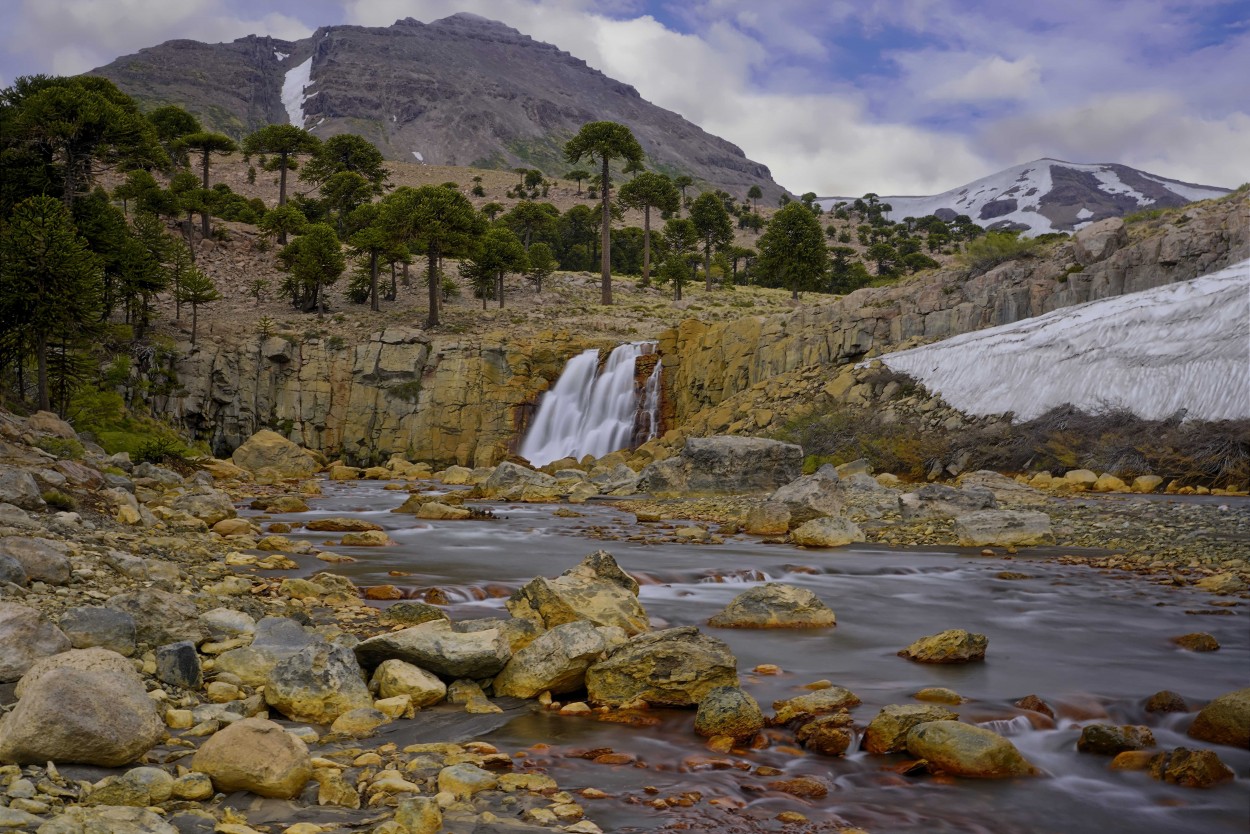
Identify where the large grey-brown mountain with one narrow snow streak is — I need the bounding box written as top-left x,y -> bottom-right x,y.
90,14 -> 783,200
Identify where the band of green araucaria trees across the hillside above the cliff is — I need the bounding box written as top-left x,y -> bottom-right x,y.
0,76 -> 995,413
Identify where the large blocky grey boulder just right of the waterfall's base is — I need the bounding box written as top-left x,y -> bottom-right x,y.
638,435 -> 803,495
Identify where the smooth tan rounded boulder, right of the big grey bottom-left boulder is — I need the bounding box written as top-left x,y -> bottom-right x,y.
191,718 -> 313,799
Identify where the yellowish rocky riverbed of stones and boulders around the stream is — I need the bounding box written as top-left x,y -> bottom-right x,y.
0,414 -> 1250,834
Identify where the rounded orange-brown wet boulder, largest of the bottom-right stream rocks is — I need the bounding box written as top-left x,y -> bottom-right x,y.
908,721 -> 1038,779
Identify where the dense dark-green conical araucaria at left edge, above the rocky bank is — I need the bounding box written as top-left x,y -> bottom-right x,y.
0,196 -> 103,411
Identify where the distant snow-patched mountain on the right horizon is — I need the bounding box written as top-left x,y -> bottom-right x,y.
820,159 -> 1230,236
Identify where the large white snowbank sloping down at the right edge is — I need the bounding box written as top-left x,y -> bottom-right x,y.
881,260 -> 1250,420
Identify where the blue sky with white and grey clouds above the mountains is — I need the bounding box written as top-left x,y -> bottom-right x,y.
0,0 -> 1250,196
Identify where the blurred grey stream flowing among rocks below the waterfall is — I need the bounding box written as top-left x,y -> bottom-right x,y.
251,481 -> 1250,834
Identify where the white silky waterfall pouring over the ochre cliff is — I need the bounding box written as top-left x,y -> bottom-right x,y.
519,341 -> 660,466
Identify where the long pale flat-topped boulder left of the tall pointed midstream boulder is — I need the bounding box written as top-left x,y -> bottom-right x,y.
355,620 -> 513,680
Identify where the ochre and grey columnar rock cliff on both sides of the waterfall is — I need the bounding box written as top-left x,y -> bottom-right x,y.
173,196 -> 1250,465
